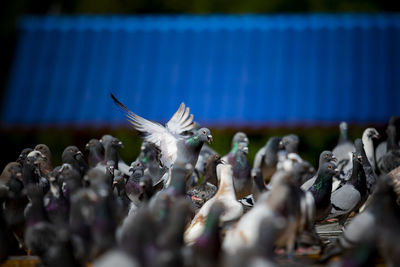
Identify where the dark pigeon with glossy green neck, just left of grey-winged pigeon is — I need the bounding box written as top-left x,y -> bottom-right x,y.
308,162 -> 336,222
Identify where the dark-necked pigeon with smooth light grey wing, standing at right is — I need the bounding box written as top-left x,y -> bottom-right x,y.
329,152 -> 368,227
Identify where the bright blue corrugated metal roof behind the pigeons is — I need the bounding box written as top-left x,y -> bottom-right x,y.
2,14 -> 400,126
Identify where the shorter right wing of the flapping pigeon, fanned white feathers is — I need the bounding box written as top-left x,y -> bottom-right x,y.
167,103 -> 194,134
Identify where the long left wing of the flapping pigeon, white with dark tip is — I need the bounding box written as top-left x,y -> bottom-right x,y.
111,94 -> 178,168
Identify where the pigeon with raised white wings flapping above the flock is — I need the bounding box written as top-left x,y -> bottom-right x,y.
111,94 -> 212,184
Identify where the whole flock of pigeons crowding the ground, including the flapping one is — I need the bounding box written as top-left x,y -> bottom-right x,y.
0,95 -> 400,267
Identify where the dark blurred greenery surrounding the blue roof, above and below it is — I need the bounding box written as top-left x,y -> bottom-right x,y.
0,0 -> 400,168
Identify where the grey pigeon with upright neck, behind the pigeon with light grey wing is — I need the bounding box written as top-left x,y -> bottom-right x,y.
332,122 -> 356,181
